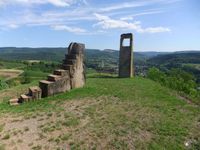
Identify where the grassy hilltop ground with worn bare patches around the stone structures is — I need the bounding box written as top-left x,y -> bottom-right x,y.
0,75 -> 200,150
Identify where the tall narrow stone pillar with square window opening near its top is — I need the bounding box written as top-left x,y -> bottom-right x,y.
119,33 -> 133,78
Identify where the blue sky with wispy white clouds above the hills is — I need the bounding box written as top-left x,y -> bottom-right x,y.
0,0 -> 200,52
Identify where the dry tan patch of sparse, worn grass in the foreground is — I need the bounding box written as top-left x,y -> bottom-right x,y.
0,96 -> 157,150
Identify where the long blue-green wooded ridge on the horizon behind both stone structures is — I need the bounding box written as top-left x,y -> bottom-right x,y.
0,47 -> 166,62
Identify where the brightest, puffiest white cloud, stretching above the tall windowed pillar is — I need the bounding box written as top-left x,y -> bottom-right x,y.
93,13 -> 170,33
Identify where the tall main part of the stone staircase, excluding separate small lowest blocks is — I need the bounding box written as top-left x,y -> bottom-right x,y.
39,43 -> 85,97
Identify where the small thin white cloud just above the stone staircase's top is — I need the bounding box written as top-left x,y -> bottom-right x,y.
52,25 -> 86,34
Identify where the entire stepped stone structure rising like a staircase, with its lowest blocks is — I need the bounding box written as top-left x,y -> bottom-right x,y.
9,43 -> 85,105
